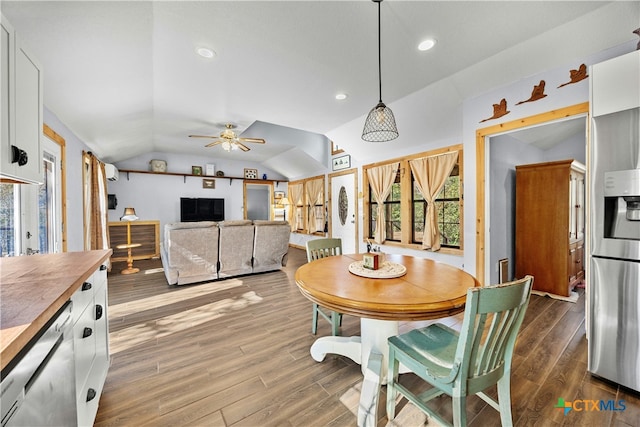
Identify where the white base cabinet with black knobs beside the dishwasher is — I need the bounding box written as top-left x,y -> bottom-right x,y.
71,265 -> 109,426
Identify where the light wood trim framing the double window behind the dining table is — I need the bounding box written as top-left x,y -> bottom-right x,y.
362,144 -> 464,255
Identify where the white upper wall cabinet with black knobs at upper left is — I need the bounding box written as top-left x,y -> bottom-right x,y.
0,16 -> 43,183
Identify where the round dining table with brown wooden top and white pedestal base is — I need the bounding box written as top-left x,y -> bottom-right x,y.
295,254 -> 479,425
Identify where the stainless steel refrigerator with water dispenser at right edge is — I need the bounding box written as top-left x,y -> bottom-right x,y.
587,108 -> 640,391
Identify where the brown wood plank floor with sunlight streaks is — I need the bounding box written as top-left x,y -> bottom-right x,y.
96,248 -> 640,427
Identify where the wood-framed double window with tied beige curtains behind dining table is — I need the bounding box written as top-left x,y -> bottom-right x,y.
363,144 -> 463,254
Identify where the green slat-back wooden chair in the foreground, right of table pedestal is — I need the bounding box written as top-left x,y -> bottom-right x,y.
387,276 -> 533,426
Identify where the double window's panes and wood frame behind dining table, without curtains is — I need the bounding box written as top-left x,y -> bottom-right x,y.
363,144 -> 463,254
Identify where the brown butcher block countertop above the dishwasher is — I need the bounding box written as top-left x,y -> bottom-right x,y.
0,249 -> 111,369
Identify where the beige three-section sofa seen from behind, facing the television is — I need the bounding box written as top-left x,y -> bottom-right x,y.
160,220 -> 291,285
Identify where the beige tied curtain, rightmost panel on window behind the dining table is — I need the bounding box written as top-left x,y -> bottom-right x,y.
409,151 -> 458,251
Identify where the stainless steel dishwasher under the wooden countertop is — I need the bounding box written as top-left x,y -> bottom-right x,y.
0,301 -> 77,427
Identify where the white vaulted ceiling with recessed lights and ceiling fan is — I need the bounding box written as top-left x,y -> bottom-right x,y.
0,0 -> 633,175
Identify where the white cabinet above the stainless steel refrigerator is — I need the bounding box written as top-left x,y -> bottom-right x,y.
590,50 -> 640,117
